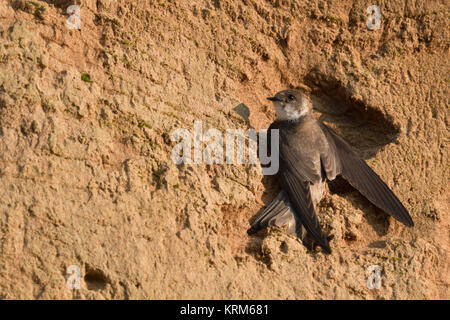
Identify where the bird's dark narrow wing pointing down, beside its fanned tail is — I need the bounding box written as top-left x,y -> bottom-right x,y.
280,168 -> 331,253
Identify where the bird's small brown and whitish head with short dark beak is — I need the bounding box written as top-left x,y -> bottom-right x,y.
267,90 -> 311,120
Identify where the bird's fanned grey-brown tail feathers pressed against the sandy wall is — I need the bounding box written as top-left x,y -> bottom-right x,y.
247,191 -> 303,240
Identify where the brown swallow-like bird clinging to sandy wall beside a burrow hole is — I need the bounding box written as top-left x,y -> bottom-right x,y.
248,90 -> 414,253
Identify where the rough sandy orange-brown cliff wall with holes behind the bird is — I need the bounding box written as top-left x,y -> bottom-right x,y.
0,0 -> 450,299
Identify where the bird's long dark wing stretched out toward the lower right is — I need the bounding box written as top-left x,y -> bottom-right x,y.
320,123 -> 414,227
